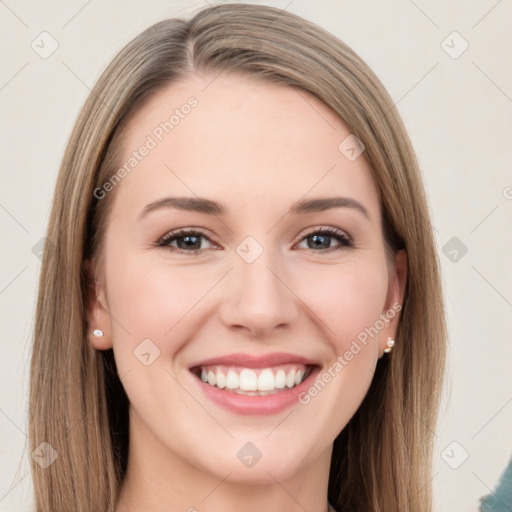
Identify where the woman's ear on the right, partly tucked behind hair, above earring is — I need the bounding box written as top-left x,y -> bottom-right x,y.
379,249 -> 407,356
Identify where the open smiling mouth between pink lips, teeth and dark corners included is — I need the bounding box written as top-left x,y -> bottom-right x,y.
190,363 -> 317,396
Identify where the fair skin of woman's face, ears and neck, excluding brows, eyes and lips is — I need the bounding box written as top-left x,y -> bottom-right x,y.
88,74 -> 406,512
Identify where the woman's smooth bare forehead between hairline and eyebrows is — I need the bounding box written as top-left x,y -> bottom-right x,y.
111,74 -> 379,222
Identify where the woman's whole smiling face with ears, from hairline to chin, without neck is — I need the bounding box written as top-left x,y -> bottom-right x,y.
89,74 -> 405,488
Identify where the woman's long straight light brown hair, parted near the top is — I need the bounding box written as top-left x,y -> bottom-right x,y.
29,4 -> 446,512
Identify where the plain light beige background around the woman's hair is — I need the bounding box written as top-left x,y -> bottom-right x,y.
0,0 -> 512,512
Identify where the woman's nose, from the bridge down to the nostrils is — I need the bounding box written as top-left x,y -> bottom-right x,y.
223,237 -> 297,335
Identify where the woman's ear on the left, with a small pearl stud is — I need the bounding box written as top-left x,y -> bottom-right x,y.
85,260 -> 112,350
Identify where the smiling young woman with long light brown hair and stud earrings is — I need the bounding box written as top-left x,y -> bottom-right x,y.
30,4 -> 445,512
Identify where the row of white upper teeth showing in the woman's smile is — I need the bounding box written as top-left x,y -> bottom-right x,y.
196,365 -> 306,396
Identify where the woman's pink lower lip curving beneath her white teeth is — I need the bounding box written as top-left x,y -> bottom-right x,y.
194,366 -> 321,416
